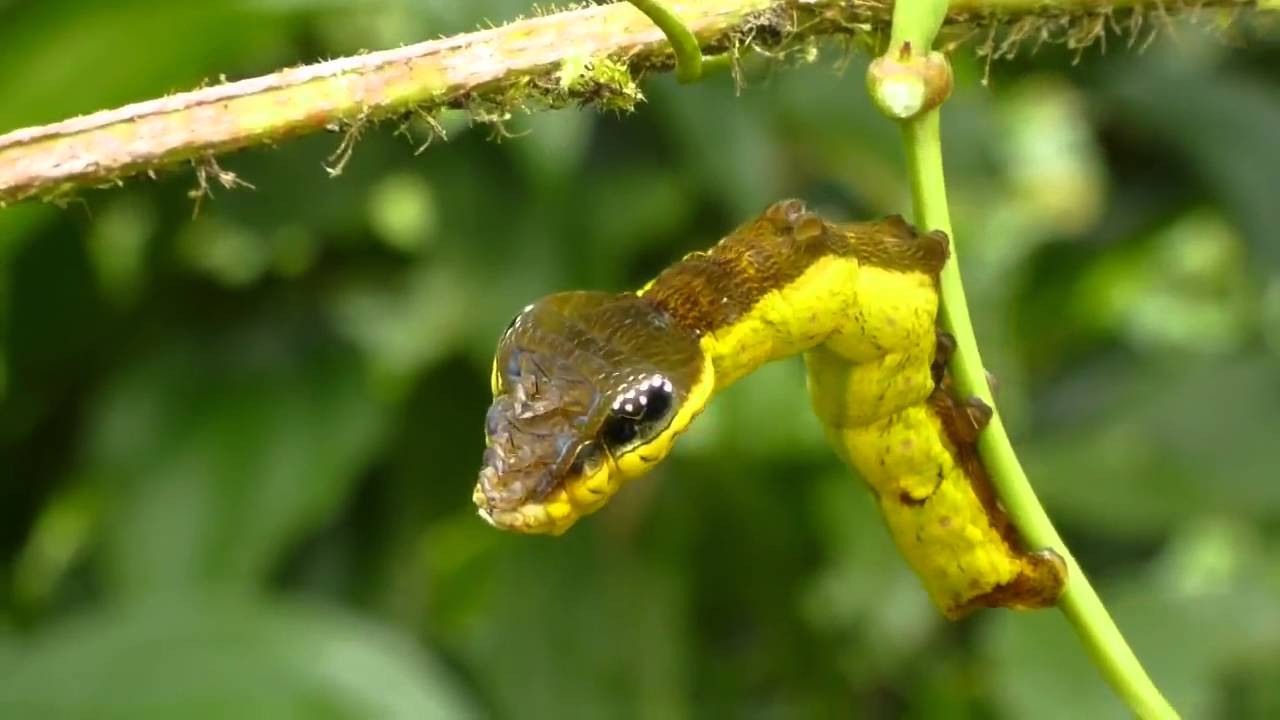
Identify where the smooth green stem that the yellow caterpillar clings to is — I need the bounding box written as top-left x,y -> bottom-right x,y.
890,0 -> 1178,719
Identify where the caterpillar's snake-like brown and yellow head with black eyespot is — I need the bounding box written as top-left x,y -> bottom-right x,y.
474,292 -> 714,534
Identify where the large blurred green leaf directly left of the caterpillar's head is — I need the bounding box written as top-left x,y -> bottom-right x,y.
82,328 -> 387,594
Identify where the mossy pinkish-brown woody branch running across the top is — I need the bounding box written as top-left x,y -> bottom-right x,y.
0,0 -> 1256,206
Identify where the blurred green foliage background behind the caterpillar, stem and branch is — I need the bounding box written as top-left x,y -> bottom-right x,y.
0,0 -> 1280,720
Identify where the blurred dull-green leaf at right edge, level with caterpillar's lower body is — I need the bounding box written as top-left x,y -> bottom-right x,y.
1020,356 -> 1280,537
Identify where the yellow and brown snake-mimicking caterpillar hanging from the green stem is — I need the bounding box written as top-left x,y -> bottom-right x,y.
472,200 -> 1066,618
